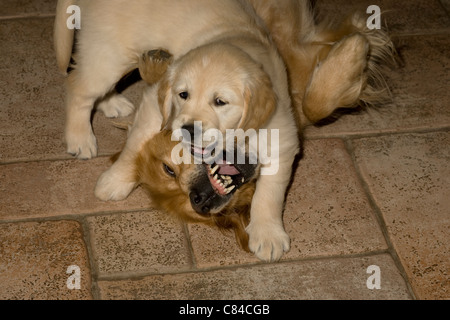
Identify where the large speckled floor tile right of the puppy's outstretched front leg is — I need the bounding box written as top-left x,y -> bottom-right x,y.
284,139 -> 387,259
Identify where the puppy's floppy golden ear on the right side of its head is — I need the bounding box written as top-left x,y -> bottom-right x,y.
238,70 -> 277,131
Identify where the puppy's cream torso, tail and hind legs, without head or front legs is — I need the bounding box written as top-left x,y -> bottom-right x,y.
55,0 -> 294,159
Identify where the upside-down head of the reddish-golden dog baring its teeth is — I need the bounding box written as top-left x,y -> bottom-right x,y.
136,130 -> 258,250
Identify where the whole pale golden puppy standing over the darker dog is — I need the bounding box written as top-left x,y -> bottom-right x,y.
55,0 -> 299,261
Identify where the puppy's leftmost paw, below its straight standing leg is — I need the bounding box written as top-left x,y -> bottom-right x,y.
66,128 -> 97,160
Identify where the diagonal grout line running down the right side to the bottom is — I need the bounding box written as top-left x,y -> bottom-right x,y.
343,138 -> 417,300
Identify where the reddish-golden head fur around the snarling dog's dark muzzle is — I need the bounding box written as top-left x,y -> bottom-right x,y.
136,130 -> 255,251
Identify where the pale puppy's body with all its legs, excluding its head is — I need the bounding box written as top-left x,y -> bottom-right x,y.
55,0 -> 299,261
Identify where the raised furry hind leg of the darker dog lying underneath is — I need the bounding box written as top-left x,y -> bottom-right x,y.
303,14 -> 396,123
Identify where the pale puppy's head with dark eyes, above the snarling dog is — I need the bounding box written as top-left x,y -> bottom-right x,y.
158,44 -> 276,132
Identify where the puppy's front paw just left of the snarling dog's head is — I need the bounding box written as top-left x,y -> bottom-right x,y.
95,167 -> 136,201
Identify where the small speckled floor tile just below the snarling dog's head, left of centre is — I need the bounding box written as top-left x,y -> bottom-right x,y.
88,211 -> 191,276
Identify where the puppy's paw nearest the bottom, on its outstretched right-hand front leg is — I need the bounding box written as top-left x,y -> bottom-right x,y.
246,222 -> 290,262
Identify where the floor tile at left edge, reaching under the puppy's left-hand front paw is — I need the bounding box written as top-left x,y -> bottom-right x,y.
0,158 -> 150,220
